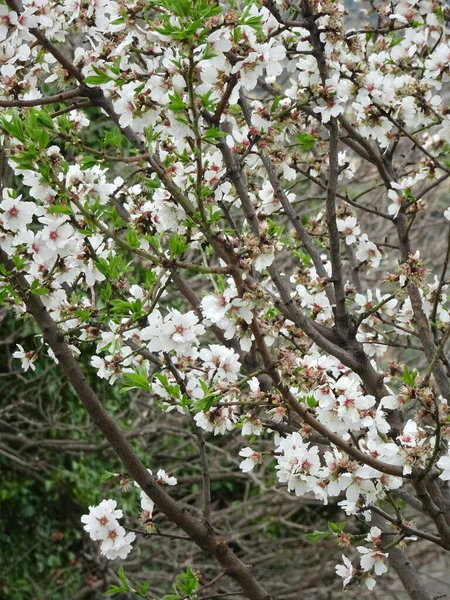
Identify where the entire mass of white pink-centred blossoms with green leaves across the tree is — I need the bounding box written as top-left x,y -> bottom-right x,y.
0,0 -> 450,589
